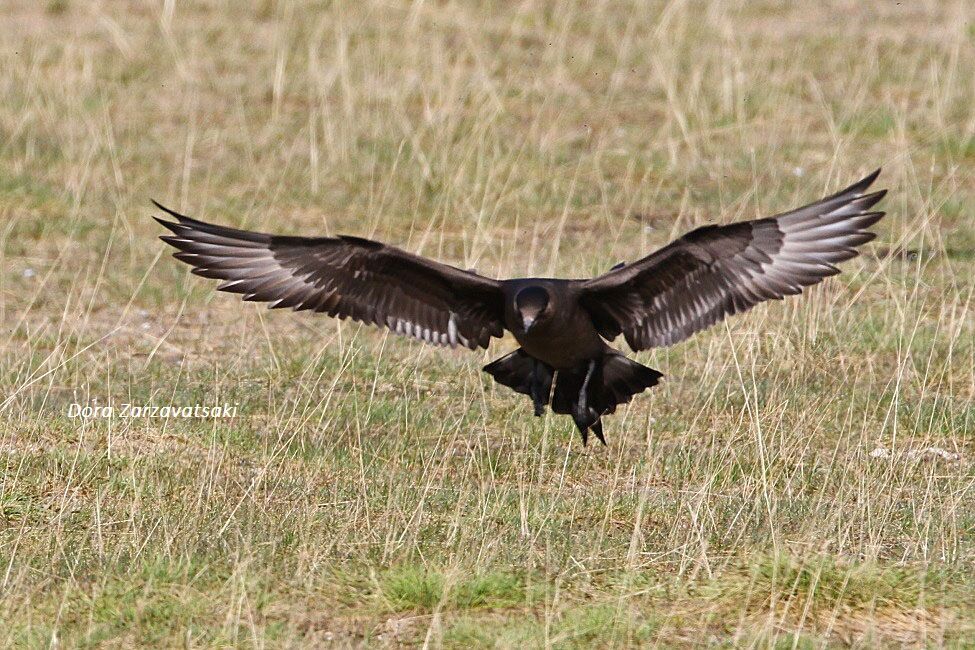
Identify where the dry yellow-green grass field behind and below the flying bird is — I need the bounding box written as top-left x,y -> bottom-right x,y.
0,0 -> 975,648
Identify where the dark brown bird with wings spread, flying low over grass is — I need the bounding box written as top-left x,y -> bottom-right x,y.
153,169 -> 886,446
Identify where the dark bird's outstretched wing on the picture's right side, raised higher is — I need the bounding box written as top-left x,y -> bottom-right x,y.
580,169 -> 886,350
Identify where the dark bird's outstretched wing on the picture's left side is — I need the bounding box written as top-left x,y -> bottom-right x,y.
153,201 -> 504,350
